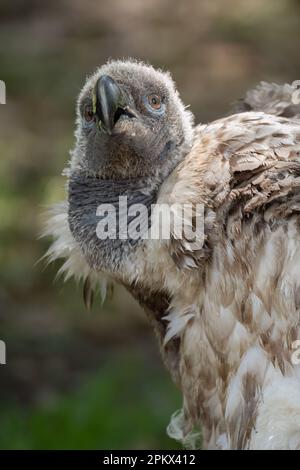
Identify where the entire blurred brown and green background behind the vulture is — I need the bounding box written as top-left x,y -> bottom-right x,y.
0,0 -> 300,449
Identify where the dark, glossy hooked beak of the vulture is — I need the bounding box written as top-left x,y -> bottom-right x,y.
94,75 -> 132,134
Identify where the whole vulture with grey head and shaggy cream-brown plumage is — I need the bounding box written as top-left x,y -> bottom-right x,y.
45,59 -> 300,450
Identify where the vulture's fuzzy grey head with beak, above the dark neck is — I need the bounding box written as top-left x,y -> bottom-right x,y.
72,60 -> 196,180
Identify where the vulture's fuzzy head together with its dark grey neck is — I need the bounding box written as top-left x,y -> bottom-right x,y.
68,61 -> 193,271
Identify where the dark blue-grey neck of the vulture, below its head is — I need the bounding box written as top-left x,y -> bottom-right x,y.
68,175 -> 158,272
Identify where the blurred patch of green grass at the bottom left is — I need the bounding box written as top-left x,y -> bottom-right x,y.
0,355 -> 180,449
